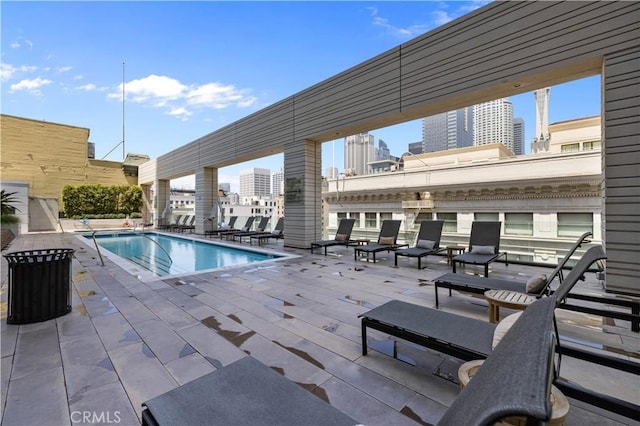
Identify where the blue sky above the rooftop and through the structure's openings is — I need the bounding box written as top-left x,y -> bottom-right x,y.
0,1 -> 600,189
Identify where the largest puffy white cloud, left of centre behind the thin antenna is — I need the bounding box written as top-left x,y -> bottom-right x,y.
108,74 -> 256,120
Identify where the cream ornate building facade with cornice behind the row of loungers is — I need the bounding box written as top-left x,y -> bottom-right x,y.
323,117 -> 603,264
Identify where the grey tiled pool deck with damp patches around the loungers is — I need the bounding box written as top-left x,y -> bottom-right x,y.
0,233 -> 640,426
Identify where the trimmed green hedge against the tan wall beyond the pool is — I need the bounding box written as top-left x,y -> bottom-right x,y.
62,185 -> 142,217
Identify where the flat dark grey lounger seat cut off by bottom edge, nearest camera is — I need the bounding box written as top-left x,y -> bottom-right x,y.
142,357 -> 359,426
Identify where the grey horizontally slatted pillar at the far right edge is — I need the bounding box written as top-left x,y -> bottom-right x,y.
602,45 -> 640,295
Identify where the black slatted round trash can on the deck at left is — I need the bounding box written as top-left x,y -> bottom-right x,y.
3,249 -> 75,324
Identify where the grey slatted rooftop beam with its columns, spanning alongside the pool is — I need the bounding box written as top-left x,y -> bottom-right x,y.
139,2 -> 640,294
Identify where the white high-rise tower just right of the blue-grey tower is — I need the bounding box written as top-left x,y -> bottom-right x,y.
473,98 -> 513,151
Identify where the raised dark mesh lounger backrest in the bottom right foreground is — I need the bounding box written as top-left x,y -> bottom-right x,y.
438,292 -> 555,426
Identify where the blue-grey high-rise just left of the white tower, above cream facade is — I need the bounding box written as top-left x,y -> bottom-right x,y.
422,106 -> 474,152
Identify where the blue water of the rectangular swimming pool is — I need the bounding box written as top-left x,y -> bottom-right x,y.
86,232 -> 281,276
